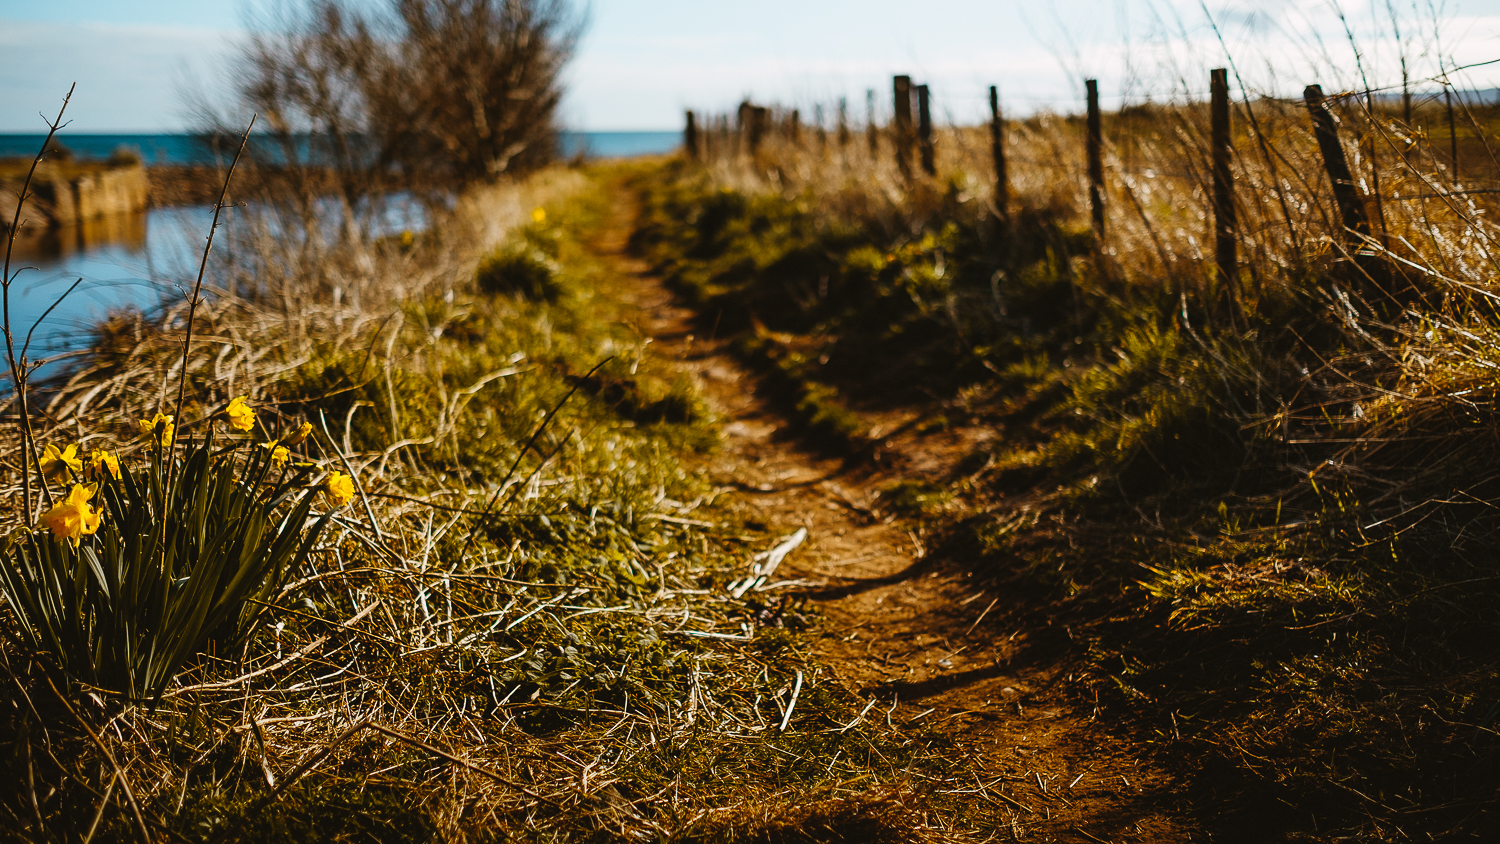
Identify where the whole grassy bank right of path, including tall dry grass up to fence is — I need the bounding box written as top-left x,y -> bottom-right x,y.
639,64 -> 1500,840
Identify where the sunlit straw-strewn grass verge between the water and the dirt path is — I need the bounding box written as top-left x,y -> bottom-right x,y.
0,160 -> 978,841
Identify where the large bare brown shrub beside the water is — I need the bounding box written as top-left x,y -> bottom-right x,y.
198,0 -> 582,230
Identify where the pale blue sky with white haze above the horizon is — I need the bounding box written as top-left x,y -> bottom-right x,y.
0,0 -> 1500,132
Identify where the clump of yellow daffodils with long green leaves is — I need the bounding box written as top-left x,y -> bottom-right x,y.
0,396 -> 357,700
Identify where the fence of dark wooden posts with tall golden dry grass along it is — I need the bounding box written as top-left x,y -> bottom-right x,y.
684,61 -> 1500,341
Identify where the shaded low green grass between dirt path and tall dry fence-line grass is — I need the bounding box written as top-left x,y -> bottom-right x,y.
638,153 -> 1500,840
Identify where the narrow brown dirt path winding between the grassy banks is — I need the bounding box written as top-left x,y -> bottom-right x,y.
597,188 -> 1206,843
